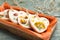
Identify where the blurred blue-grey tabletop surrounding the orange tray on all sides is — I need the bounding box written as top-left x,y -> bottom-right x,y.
0,0 -> 60,40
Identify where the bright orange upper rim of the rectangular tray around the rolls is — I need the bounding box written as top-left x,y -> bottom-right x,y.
0,2 -> 57,39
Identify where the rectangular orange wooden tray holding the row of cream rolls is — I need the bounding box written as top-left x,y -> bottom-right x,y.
0,2 -> 57,40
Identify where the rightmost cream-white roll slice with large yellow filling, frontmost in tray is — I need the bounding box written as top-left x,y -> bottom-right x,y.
30,17 -> 49,33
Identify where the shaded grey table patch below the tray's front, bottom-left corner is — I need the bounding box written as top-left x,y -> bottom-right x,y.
0,29 -> 26,40
